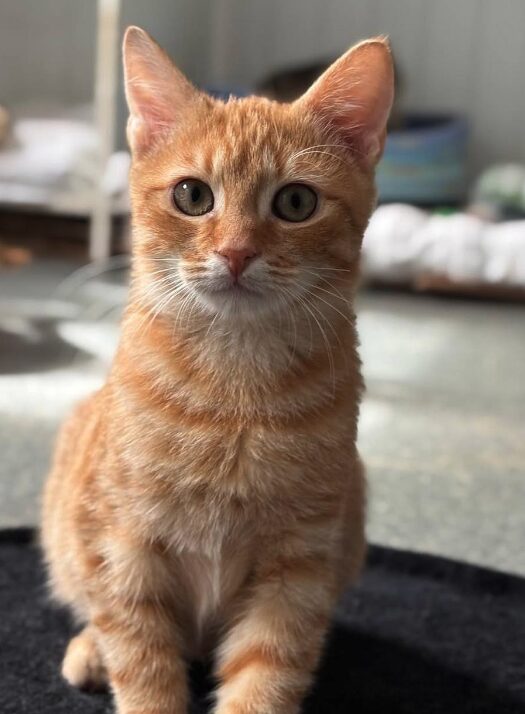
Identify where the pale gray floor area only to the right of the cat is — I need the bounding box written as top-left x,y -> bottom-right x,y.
359,286 -> 525,574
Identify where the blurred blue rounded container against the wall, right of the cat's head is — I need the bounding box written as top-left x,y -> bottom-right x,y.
377,114 -> 468,205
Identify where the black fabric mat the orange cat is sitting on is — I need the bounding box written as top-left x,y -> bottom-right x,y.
0,530 -> 525,714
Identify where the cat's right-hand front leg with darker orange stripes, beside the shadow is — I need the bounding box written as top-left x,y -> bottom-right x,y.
211,524 -> 338,714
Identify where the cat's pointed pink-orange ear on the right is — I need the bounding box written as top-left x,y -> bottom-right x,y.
297,37 -> 394,166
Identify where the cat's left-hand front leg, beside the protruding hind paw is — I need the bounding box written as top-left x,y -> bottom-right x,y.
90,535 -> 188,714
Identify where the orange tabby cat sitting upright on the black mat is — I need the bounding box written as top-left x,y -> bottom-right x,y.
42,28 -> 393,714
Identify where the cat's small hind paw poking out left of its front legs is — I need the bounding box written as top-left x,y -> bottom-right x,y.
62,627 -> 107,690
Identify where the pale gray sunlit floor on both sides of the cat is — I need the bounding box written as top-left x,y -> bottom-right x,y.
0,262 -> 525,575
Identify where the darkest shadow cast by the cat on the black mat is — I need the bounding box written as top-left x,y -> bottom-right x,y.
186,624 -> 525,714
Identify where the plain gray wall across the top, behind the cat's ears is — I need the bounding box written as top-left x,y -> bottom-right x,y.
0,0 -> 525,169
